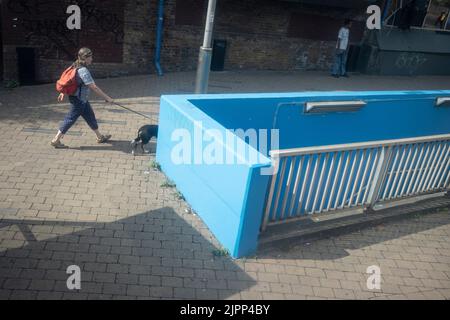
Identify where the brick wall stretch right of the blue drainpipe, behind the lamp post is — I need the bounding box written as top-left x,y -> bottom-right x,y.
162,0 -> 370,70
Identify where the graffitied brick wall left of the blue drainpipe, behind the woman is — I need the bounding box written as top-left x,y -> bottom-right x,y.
2,0 -> 156,82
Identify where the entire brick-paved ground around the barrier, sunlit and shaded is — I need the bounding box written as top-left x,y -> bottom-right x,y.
0,72 -> 450,299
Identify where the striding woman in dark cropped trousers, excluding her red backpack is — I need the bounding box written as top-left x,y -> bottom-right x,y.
50,48 -> 114,148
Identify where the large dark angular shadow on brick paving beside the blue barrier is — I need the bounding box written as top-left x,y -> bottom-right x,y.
0,207 -> 255,299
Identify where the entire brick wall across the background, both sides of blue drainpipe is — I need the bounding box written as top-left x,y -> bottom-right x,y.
2,0 -> 370,82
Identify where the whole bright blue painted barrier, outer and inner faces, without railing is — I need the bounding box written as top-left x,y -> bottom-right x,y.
157,90 -> 450,258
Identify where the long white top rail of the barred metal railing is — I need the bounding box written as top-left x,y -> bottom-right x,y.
269,134 -> 450,157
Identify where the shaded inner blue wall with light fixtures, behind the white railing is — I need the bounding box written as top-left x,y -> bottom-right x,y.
191,90 -> 450,149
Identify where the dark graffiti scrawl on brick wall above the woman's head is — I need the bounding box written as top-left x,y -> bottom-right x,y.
6,0 -> 124,58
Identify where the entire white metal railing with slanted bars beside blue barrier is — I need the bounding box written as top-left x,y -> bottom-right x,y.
261,134 -> 450,231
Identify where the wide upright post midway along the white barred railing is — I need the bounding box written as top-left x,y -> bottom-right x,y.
364,146 -> 393,212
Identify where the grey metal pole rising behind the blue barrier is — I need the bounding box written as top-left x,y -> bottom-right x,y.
195,0 -> 217,93
